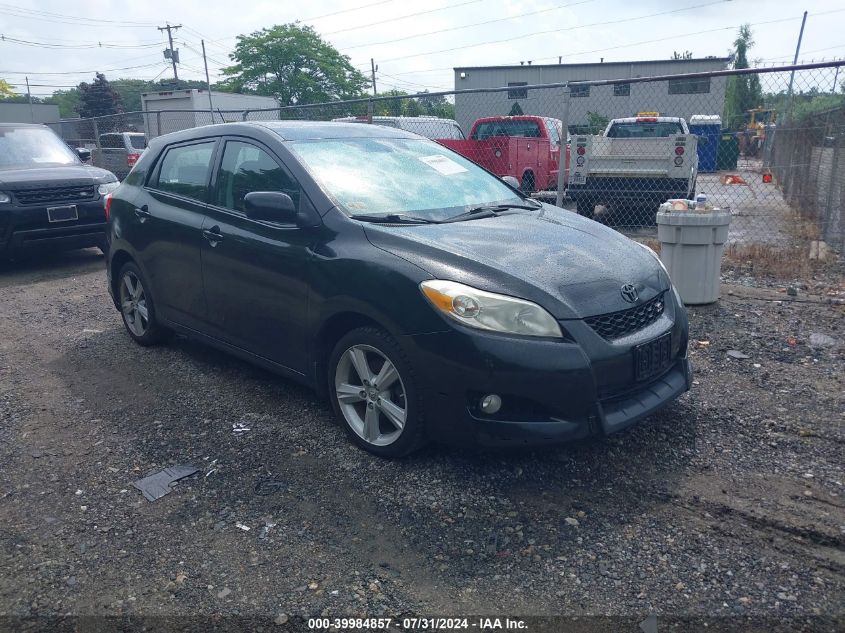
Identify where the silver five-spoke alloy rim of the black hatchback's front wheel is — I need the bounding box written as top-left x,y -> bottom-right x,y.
334,345 -> 408,446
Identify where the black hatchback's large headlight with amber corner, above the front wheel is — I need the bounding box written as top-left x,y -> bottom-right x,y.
420,279 -> 563,338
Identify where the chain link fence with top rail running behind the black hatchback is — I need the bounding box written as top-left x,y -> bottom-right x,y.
63,62 -> 845,266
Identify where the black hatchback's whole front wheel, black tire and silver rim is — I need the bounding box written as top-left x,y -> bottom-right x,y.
329,327 -> 425,457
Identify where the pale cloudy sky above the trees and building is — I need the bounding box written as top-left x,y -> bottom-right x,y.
0,0 -> 845,96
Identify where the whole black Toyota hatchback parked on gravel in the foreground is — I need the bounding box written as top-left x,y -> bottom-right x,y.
106,122 -> 691,456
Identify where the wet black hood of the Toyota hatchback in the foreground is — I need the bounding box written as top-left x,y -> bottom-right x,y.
365,205 -> 669,319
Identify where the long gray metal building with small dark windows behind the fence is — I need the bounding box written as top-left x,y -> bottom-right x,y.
454,57 -> 731,132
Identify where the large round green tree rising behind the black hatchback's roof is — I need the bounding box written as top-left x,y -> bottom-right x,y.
222,23 -> 369,106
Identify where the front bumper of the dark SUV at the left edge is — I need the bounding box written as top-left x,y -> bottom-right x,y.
0,198 -> 106,257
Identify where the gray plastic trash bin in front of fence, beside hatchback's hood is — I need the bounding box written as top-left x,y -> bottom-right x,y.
657,209 -> 731,305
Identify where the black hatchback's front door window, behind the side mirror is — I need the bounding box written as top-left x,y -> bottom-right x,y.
214,141 -> 300,213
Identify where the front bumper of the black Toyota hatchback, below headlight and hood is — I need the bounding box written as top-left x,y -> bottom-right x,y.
403,298 -> 692,447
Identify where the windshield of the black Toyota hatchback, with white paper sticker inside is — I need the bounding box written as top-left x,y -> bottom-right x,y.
289,138 -> 524,220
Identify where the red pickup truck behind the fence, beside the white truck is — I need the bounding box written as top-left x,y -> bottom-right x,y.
437,116 -> 569,193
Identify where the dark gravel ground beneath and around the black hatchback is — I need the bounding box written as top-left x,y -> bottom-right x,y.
0,251 -> 845,631
